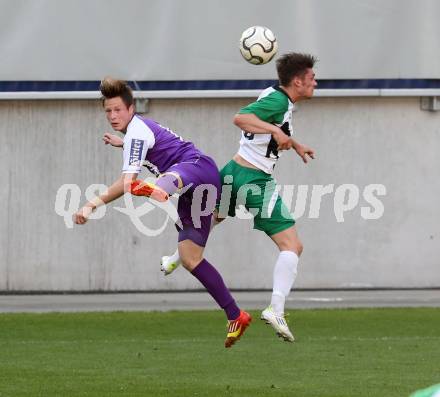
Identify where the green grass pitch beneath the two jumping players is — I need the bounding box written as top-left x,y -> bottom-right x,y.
0,308 -> 440,397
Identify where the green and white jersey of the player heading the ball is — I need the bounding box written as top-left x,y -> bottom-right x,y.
238,85 -> 293,174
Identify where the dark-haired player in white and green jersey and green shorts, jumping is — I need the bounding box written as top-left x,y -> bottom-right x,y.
161,53 -> 317,342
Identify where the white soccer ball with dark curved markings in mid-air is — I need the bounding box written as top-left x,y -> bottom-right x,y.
240,26 -> 278,65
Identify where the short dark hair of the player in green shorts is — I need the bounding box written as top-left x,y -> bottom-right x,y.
276,52 -> 318,86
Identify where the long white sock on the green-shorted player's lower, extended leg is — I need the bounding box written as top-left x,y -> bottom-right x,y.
270,251 -> 298,314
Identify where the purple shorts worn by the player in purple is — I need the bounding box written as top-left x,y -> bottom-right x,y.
166,155 -> 221,247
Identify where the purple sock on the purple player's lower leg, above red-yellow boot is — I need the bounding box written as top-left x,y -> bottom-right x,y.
191,259 -> 240,320
